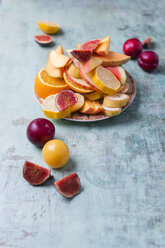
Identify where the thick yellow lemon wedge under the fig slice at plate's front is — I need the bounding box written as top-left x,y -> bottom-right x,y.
41,93 -> 84,119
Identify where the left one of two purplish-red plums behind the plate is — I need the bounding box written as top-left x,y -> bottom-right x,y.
123,38 -> 143,59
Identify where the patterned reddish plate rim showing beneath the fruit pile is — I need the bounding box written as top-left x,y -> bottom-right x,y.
35,72 -> 136,122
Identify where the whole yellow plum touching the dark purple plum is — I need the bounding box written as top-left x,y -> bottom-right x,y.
42,139 -> 69,169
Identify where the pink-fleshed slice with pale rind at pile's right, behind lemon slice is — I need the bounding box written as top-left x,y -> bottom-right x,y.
106,66 -> 127,85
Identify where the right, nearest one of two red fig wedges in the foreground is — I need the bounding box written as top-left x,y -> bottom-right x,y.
54,173 -> 81,198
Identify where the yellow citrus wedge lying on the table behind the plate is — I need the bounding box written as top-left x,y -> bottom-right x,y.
37,21 -> 60,34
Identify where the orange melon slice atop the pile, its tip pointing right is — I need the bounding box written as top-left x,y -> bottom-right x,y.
93,51 -> 131,66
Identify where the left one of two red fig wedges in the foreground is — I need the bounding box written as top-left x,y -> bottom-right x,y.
23,161 -> 50,185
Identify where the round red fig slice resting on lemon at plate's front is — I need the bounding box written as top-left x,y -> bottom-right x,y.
56,90 -> 78,111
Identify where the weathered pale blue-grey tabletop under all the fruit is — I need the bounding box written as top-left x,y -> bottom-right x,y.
0,0 -> 165,248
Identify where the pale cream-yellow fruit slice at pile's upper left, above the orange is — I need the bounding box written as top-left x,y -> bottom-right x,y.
50,50 -> 71,68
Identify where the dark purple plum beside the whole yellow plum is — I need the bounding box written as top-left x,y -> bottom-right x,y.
27,118 -> 55,147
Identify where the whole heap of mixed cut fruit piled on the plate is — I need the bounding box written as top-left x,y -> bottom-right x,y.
34,36 -> 131,119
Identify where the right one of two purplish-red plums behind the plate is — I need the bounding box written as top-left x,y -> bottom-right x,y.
138,51 -> 159,72
